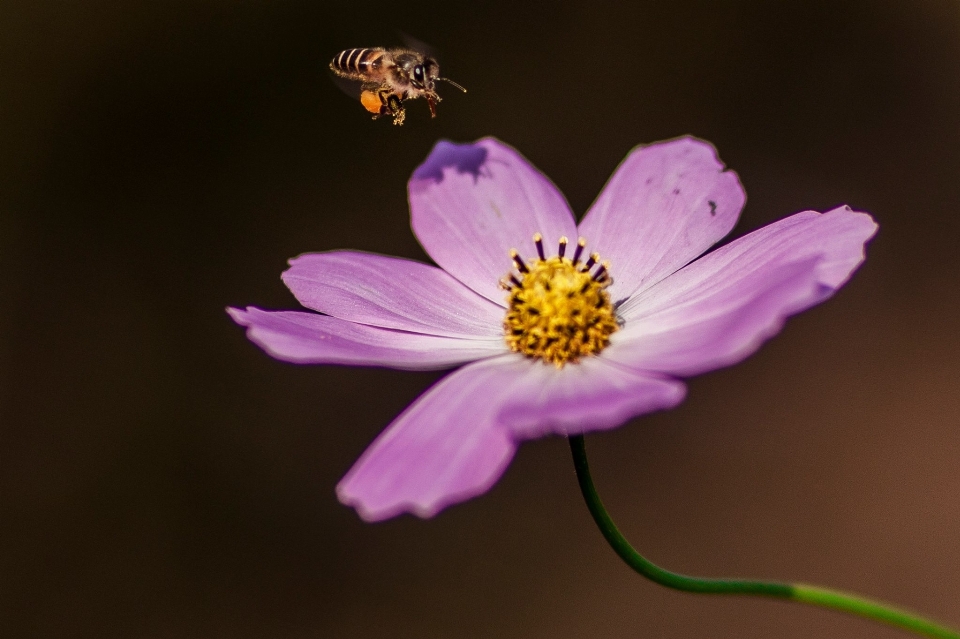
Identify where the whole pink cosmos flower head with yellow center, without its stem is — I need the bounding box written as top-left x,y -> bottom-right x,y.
228,137 -> 877,520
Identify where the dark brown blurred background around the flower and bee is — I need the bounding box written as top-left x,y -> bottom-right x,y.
0,0 -> 960,639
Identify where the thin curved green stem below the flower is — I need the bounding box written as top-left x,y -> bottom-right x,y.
570,435 -> 960,639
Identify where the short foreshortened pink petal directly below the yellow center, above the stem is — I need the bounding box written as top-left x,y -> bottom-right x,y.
500,356 -> 686,439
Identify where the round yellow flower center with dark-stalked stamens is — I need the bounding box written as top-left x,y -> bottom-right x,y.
501,233 -> 618,368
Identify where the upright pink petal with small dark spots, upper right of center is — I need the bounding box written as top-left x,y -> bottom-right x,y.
580,137 -> 746,300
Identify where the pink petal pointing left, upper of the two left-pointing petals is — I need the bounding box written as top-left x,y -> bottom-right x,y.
283,251 -> 504,338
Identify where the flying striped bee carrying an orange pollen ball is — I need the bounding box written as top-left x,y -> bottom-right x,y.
330,48 -> 467,125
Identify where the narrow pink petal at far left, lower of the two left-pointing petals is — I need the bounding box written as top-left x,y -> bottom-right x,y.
227,306 -> 507,370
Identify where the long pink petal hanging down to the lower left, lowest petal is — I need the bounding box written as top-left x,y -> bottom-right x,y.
337,355 -> 516,521
